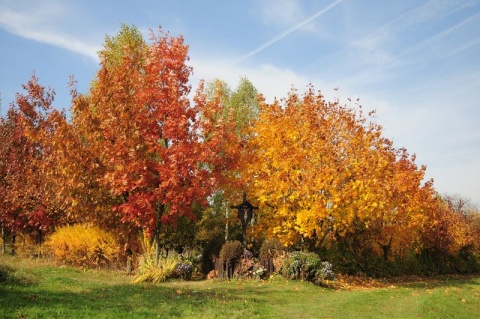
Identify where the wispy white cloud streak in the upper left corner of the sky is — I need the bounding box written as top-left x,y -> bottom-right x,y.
0,2 -> 101,61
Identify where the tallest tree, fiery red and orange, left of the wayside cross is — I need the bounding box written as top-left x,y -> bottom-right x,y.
73,25 -> 234,262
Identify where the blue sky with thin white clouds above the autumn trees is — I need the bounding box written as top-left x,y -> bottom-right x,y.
0,0 -> 480,203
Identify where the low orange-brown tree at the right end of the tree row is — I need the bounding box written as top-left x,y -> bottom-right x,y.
362,159 -> 475,266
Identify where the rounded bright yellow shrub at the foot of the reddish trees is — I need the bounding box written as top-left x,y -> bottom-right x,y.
45,225 -> 120,267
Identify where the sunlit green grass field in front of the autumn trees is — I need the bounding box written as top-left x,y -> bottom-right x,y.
0,256 -> 480,319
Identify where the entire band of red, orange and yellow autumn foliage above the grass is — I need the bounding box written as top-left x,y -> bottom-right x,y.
0,25 -> 480,281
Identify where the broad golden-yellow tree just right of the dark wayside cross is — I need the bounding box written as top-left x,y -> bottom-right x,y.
246,87 -> 436,258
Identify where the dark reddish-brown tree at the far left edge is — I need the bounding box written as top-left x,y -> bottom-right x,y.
0,75 -> 62,252
